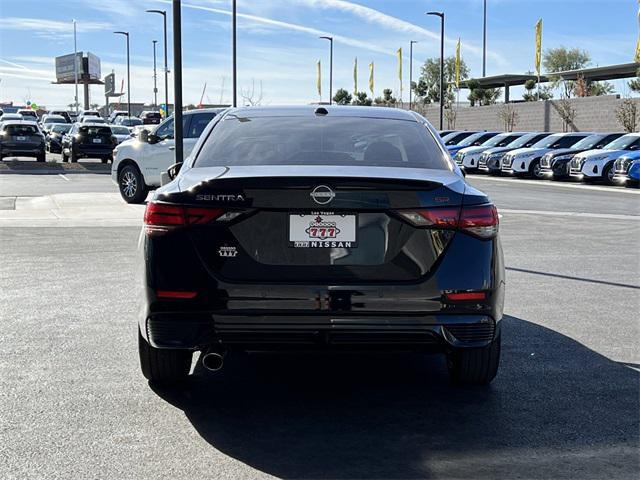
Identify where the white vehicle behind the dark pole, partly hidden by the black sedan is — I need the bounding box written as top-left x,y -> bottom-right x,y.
111,108 -> 224,203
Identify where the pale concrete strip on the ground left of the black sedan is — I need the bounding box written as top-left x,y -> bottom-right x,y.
0,193 -> 145,228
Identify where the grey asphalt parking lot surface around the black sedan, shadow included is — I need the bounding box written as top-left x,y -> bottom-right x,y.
0,167 -> 640,479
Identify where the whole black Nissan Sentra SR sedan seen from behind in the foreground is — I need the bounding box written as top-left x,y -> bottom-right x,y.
139,106 -> 505,384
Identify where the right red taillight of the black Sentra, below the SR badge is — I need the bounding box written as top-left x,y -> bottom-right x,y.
398,204 -> 499,238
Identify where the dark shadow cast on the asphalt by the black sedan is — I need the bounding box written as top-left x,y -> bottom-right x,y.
153,317 -> 640,478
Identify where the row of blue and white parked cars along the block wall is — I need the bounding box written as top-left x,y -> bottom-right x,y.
440,130 -> 640,185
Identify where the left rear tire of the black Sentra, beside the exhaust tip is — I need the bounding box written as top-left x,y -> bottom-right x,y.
138,331 -> 193,385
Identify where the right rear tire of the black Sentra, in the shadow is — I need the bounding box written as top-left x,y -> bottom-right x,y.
447,334 -> 501,385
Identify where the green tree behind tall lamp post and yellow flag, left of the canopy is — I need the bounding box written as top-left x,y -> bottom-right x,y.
411,55 -> 469,104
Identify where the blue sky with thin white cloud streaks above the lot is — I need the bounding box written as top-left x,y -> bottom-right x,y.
0,0 -> 638,108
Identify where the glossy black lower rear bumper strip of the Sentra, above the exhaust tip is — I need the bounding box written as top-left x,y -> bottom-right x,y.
144,312 -> 499,350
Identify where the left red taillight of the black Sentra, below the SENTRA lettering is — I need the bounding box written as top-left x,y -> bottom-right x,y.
144,202 -> 225,235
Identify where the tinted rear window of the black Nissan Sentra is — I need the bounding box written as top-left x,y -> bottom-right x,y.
195,115 -> 449,170
